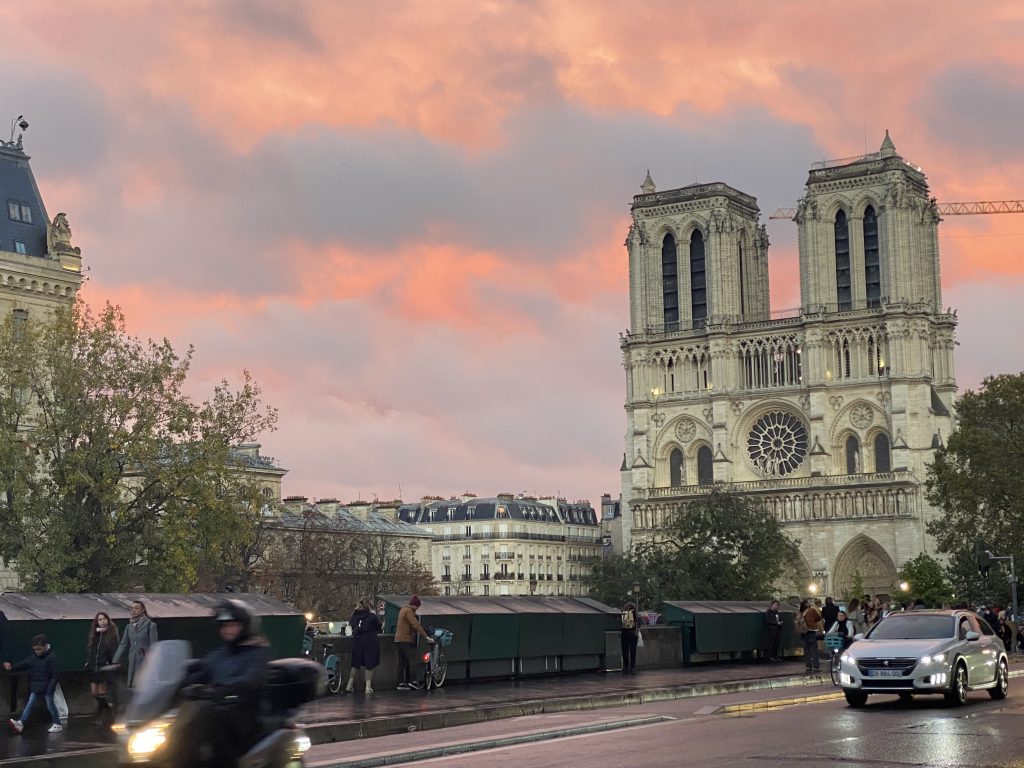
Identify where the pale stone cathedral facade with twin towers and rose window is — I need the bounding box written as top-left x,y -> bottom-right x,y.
621,133 -> 956,597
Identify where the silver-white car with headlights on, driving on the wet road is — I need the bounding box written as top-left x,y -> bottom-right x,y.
839,610 -> 1010,707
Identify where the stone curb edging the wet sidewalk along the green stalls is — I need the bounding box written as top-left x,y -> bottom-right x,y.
302,675 -> 831,744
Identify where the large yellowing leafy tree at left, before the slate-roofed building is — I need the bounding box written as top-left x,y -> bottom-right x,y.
0,301 -> 276,592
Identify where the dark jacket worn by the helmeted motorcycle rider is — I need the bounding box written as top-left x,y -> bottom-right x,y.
185,635 -> 270,713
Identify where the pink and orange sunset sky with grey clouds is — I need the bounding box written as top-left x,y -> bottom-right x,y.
0,0 -> 1024,505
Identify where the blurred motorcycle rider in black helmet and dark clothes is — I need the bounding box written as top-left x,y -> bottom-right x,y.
172,599 -> 269,768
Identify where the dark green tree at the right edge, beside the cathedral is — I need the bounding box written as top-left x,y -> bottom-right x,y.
928,374 -> 1024,577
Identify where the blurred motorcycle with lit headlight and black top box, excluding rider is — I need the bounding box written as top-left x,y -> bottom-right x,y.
114,640 -> 324,768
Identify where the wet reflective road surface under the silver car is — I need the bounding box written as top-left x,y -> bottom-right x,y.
308,682 -> 1024,768
